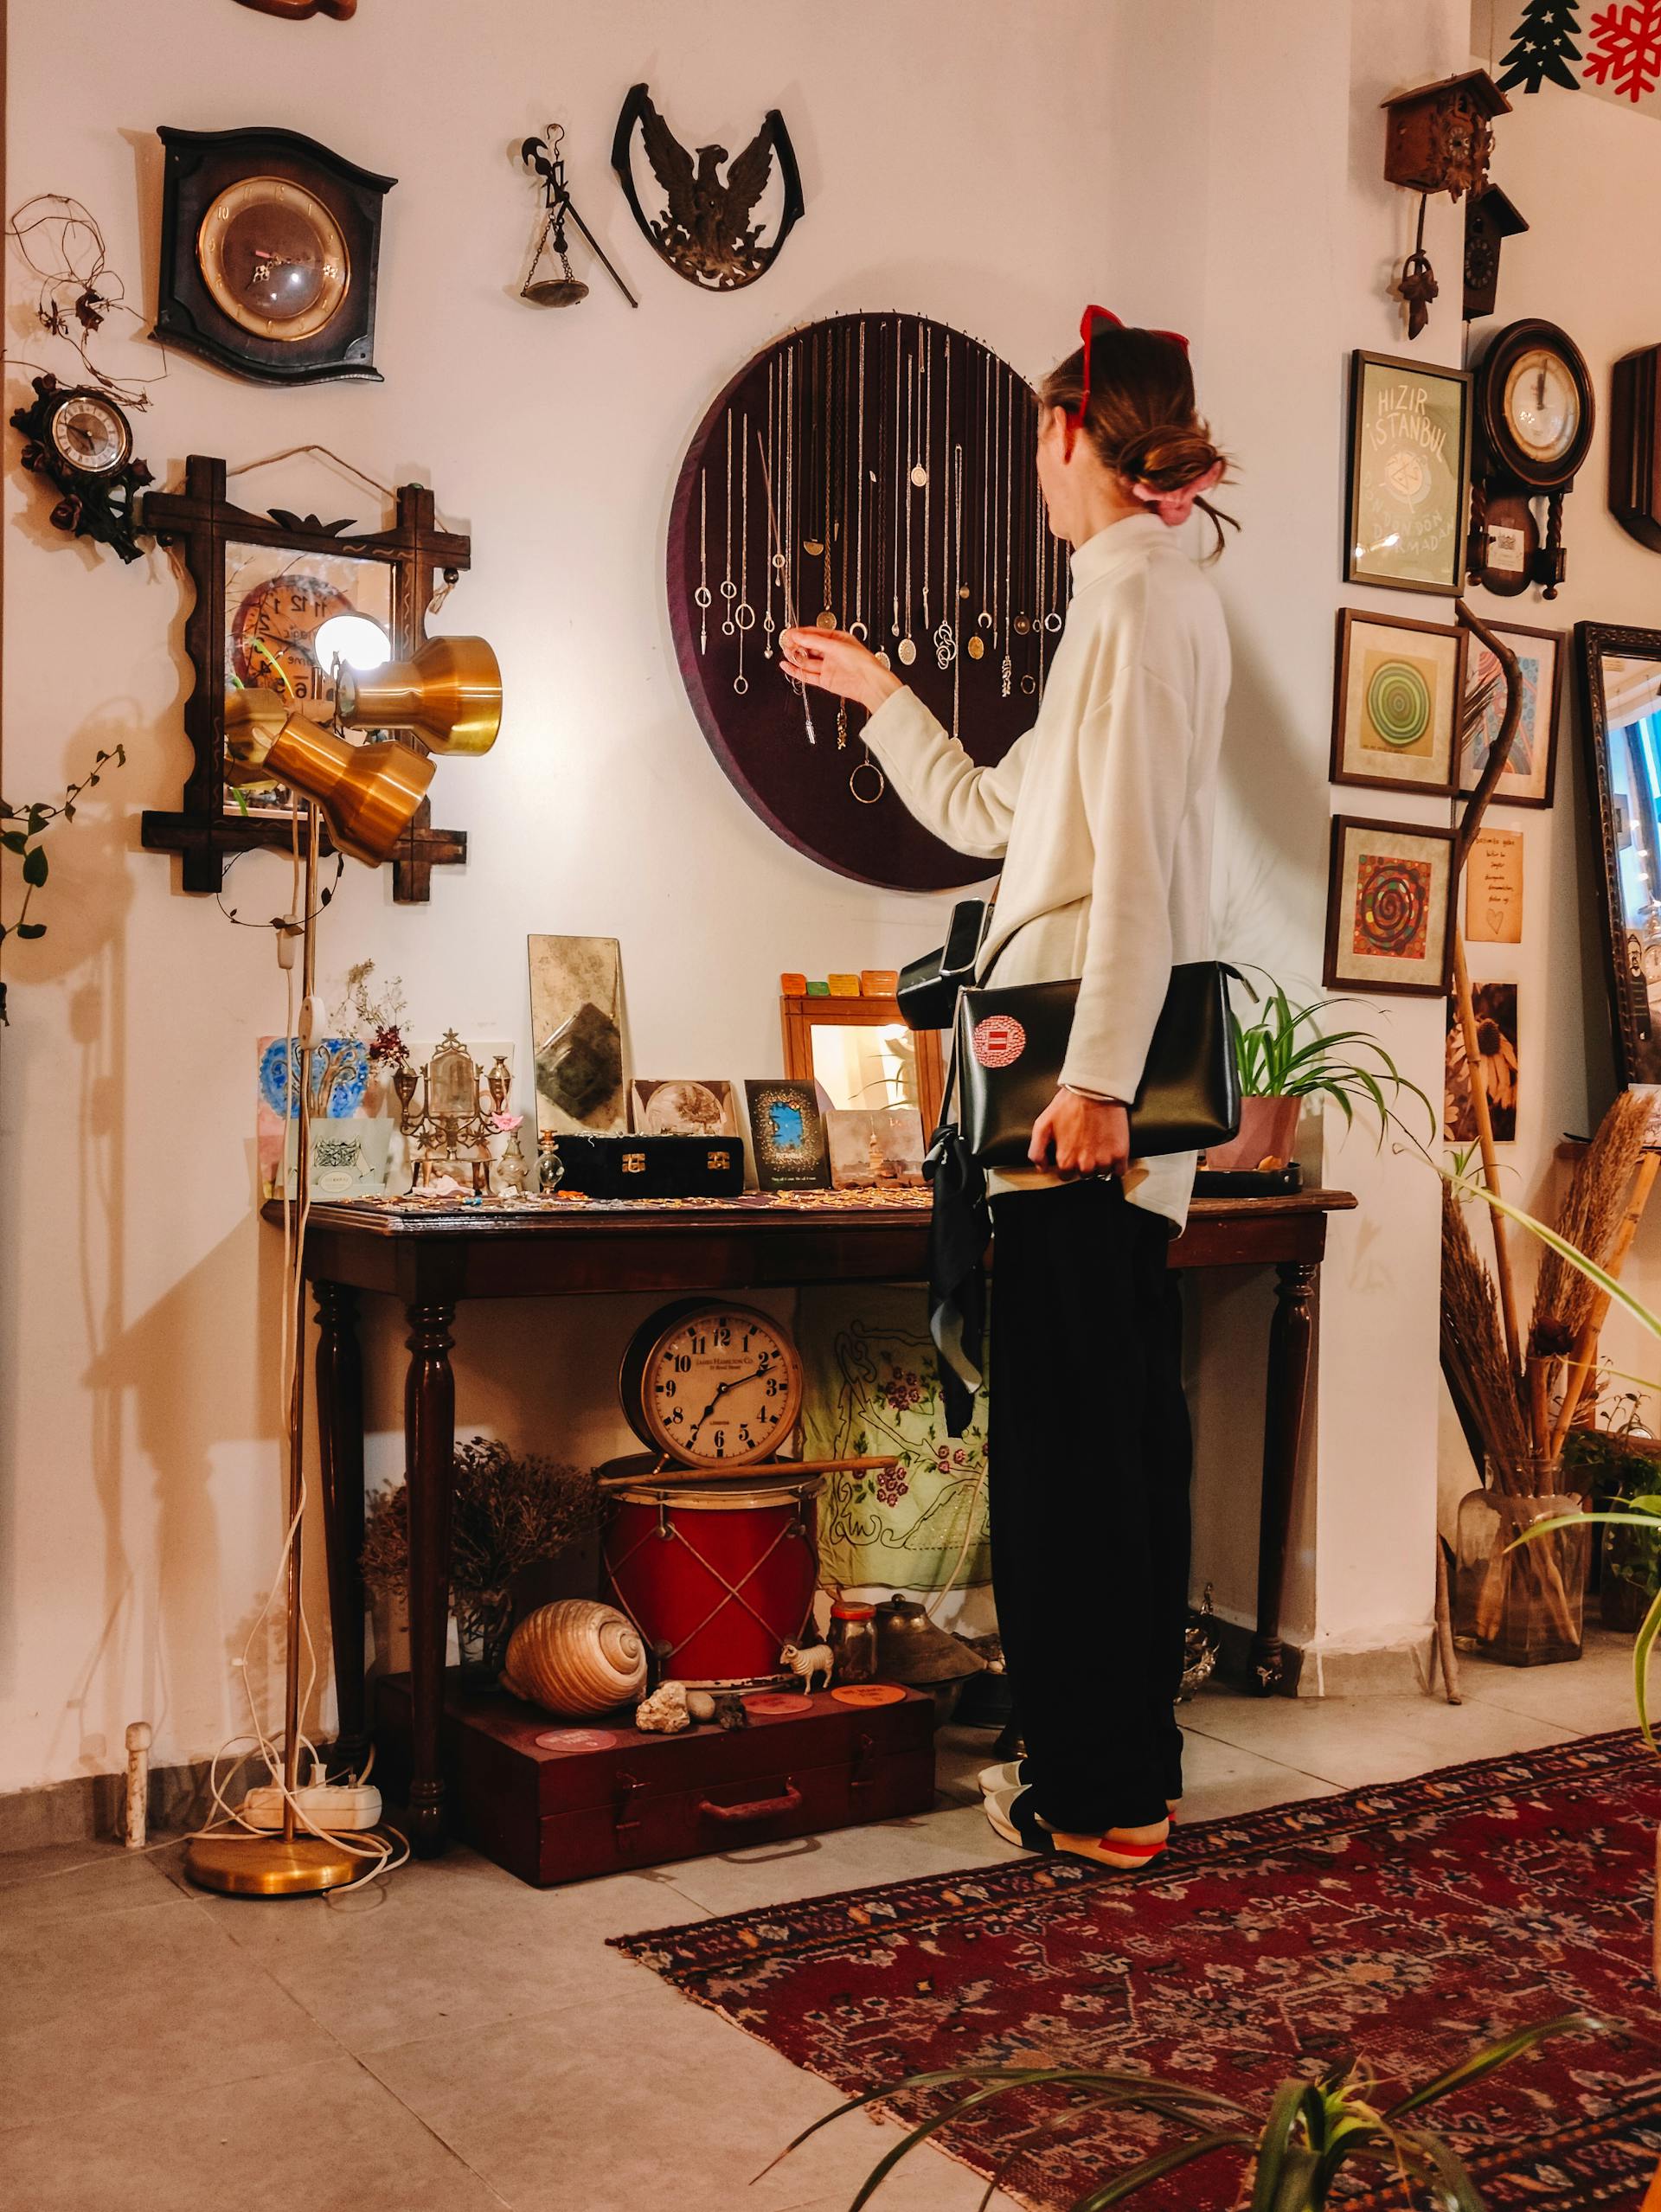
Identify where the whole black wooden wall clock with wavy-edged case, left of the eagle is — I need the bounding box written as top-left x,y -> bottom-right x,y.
151,126 -> 398,385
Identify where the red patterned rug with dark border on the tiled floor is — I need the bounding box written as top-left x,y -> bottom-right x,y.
617,1730 -> 1661,2212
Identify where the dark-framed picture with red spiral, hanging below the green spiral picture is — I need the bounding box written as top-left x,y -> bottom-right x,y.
1320,814 -> 1453,997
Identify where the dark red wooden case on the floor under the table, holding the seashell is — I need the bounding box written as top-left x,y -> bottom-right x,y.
376,1670 -> 933,1889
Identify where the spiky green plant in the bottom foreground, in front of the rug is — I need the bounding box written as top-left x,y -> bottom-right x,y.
790,2013 -> 1621,2212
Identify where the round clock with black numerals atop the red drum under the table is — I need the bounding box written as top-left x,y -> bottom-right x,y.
624,1303 -> 800,1466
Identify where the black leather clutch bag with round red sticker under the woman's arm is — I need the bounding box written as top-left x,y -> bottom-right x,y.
955,960 -> 1241,1168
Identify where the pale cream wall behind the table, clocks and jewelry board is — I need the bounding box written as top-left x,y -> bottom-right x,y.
0,0 -> 1521,1787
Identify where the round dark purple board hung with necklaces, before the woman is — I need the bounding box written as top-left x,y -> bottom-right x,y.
668,314 -> 1068,891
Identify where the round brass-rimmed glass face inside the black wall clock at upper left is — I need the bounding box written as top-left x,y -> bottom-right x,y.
197,177 -> 351,345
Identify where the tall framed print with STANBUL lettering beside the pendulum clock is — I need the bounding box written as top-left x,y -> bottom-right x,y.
1344,352 -> 1471,597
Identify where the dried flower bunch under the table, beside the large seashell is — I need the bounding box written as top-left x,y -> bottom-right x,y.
362,1435 -> 600,1661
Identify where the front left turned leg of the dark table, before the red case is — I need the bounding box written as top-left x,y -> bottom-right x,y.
405,1305 -> 456,1858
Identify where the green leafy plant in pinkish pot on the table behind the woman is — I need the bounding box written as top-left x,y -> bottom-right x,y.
1205,969 -> 1435,1168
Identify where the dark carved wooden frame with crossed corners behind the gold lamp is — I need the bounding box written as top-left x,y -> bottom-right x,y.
142,453 -> 471,902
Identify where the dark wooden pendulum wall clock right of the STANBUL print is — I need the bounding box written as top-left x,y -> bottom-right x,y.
1469,318 -> 1597,599
